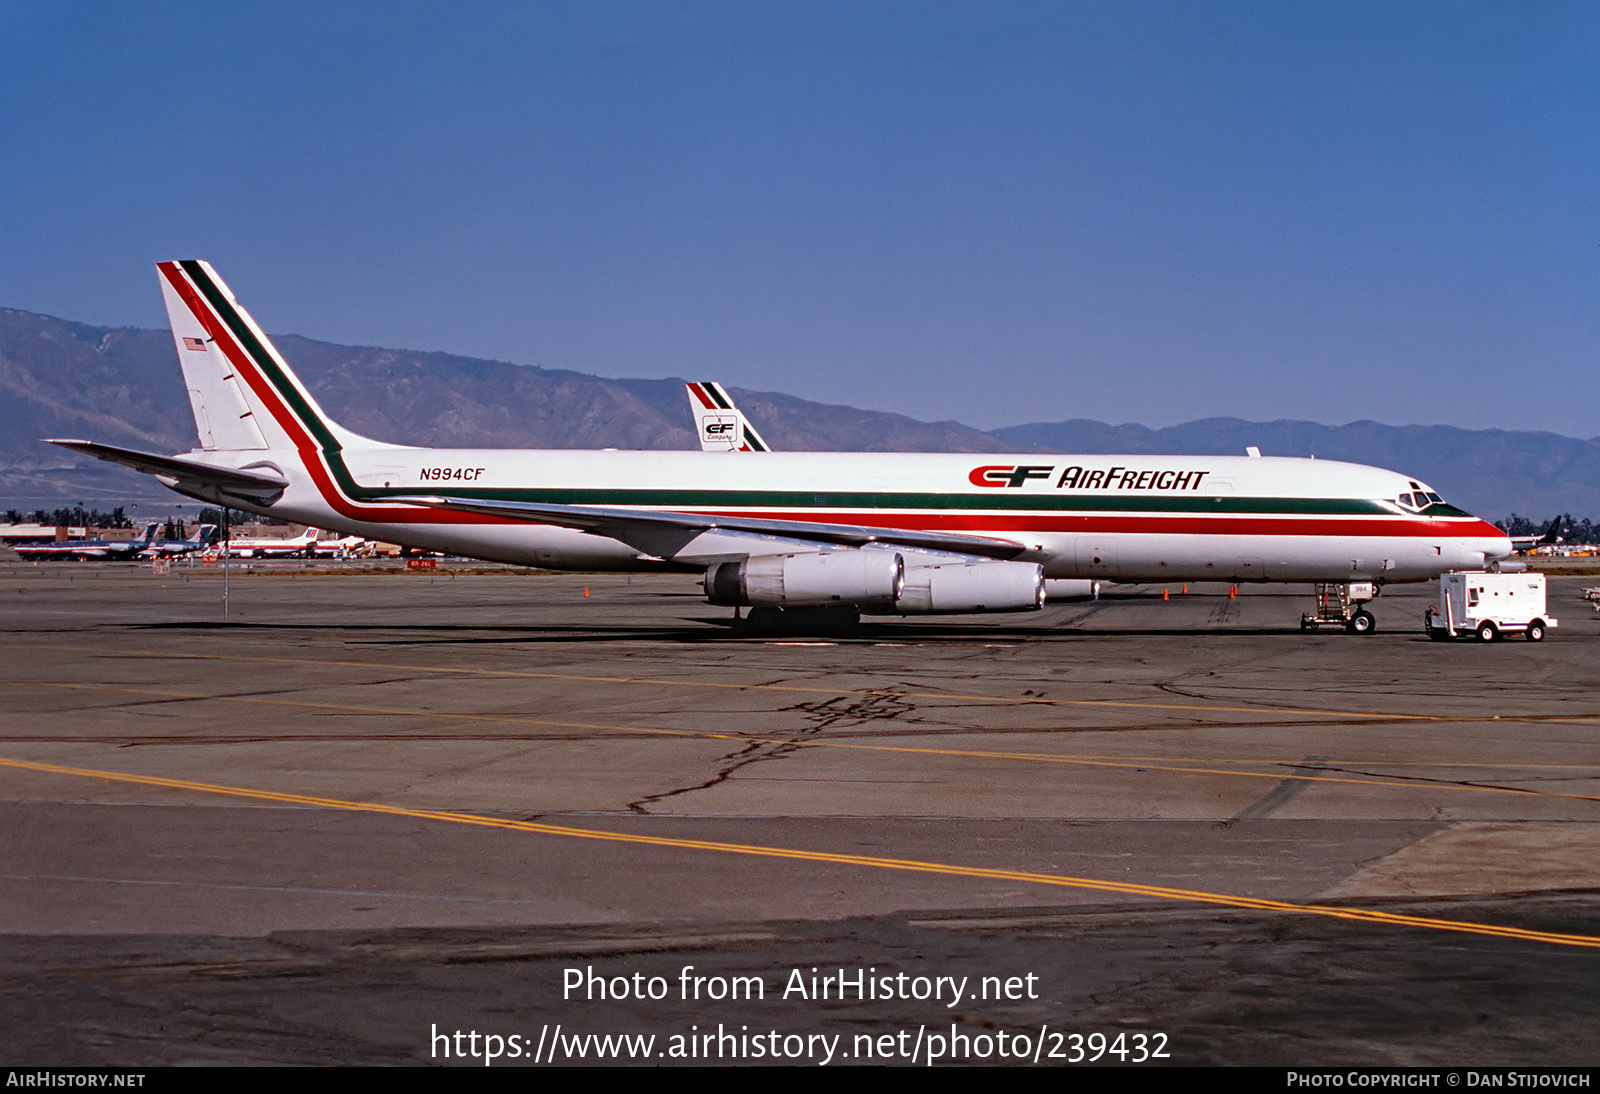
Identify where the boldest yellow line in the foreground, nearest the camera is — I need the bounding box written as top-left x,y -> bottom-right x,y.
9,757 -> 1600,948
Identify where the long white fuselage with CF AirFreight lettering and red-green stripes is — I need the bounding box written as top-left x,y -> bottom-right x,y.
178,446 -> 1510,582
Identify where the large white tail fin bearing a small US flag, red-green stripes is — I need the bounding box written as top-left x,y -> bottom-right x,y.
157,259 -> 387,451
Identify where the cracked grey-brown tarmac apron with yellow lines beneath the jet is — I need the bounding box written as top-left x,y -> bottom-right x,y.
0,563 -> 1600,1065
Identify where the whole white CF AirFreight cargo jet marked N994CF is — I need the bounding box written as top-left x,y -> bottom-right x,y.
40,261 -> 1512,630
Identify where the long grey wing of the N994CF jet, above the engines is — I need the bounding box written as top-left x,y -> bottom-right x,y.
390,494 -> 1027,558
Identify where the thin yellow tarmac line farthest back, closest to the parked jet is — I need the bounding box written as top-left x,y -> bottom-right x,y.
18,643 -> 1600,723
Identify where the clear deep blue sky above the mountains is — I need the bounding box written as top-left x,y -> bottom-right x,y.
0,0 -> 1600,437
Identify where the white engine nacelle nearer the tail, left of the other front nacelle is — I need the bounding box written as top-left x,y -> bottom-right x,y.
706,547 -> 906,608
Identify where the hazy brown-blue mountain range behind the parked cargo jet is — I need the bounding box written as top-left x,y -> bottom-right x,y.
0,309 -> 1600,520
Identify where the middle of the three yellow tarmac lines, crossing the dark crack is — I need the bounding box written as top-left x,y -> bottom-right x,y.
13,681 -> 1600,801
